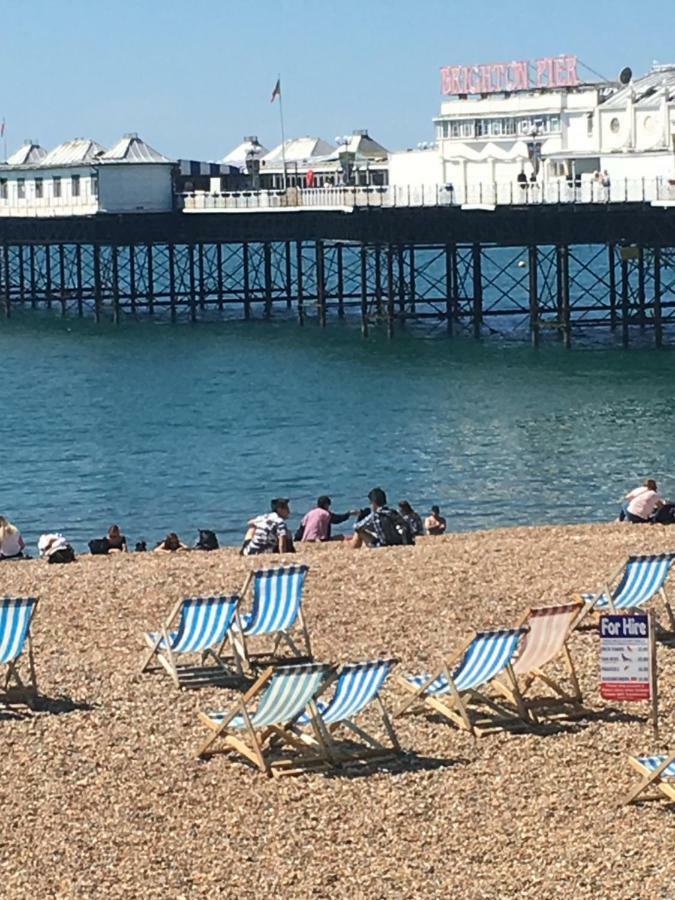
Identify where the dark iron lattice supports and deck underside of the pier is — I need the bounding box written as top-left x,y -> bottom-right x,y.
0,204 -> 675,346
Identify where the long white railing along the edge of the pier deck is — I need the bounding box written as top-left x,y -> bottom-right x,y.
181,178 -> 675,212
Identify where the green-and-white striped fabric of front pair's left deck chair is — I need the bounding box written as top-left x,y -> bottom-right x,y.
208,663 -> 332,730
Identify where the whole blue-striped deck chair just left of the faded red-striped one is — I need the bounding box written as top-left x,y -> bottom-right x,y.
396,628 -> 529,737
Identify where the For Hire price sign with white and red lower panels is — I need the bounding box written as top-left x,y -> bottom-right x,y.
600,613 -> 655,701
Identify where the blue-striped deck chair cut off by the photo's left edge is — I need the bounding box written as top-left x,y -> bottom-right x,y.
0,597 -> 38,706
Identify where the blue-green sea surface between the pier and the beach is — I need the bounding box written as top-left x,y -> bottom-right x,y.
0,312 -> 675,548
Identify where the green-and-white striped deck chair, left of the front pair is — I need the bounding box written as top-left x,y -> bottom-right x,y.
197,663 -> 335,777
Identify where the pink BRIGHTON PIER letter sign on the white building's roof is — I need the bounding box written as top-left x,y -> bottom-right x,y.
441,56 -> 579,94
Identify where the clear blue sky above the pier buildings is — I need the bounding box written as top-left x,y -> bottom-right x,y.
0,0 -> 675,159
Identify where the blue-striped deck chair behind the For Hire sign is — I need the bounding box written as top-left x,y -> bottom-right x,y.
576,553 -> 675,631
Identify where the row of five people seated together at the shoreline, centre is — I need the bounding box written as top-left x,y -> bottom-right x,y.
241,487 -> 447,556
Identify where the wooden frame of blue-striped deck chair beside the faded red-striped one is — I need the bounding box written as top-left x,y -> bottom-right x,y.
394,635 -> 532,738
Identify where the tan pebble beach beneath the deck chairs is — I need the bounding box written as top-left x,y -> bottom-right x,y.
0,524 -> 675,900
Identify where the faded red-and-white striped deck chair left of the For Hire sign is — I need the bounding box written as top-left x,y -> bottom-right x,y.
500,602 -> 583,714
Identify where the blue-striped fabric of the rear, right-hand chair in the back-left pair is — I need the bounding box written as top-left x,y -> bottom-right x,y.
242,565 -> 308,637
